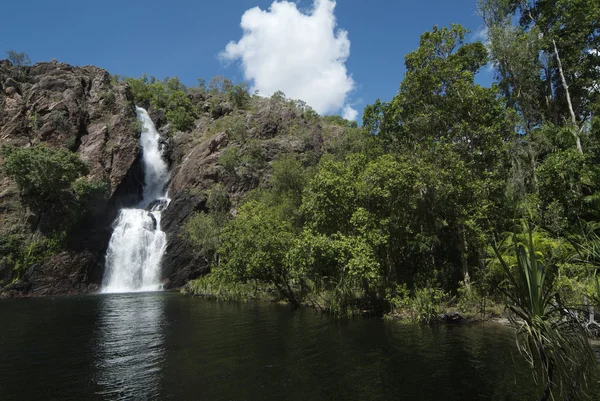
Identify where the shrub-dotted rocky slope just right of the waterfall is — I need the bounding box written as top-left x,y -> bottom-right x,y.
162,99 -> 323,287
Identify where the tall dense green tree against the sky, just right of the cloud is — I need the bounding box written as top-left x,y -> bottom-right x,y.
363,25 -> 514,281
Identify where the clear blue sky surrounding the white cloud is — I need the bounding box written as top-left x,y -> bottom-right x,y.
0,0 -> 491,118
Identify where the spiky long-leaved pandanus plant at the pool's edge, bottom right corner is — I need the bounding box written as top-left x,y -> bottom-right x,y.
492,223 -> 597,401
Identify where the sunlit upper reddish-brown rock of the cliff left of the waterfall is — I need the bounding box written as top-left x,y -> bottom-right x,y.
0,61 -> 139,199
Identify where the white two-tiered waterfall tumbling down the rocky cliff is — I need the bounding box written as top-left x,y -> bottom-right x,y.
101,107 -> 170,293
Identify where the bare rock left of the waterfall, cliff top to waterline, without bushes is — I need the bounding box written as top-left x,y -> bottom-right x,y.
0,60 -> 143,294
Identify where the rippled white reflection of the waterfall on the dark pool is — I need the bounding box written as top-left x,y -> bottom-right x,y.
94,293 -> 165,400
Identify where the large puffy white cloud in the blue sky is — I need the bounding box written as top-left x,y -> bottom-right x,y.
220,0 -> 355,115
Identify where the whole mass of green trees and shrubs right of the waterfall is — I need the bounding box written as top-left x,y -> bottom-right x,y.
179,21 -> 600,366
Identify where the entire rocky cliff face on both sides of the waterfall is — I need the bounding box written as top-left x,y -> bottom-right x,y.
0,61 -> 335,295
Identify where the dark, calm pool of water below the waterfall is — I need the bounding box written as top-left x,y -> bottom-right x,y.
0,293 -> 535,401
